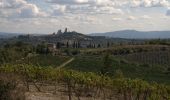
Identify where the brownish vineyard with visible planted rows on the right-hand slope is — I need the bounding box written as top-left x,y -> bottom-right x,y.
121,51 -> 170,66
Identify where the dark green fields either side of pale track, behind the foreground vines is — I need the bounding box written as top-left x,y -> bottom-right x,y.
9,45 -> 170,84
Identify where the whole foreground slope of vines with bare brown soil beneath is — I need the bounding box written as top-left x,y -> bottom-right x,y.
0,65 -> 170,100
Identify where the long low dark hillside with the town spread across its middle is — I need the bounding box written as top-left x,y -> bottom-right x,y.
3,30 -> 144,48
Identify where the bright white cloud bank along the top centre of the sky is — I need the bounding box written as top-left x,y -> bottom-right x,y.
47,0 -> 123,15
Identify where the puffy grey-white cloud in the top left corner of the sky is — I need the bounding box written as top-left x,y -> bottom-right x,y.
0,0 -> 47,18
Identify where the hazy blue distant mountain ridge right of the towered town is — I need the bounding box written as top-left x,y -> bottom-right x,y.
90,30 -> 170,39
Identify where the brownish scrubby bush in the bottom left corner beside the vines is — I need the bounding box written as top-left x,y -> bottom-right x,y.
0,73 -> 25,100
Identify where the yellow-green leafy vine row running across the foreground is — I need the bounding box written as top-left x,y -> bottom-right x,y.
0,65 -> 170,100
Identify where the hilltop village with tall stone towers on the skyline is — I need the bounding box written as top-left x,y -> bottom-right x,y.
17,28 -> 120,49
